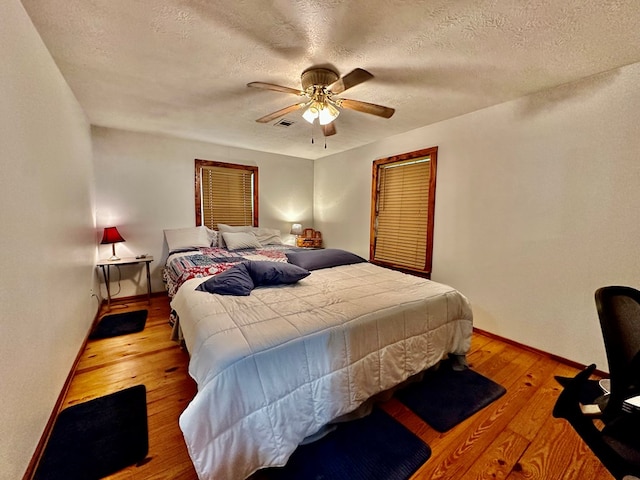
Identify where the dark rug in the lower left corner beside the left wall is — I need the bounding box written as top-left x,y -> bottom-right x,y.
33,385 -> 149,480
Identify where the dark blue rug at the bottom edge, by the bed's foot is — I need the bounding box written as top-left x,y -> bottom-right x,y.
251,408 -> 431,480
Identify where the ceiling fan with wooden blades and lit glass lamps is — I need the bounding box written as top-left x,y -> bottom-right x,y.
247,67 -> 395,137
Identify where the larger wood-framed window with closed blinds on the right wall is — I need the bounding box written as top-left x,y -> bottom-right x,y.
369,147 -> 438,276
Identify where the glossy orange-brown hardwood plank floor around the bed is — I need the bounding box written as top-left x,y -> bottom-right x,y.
64,296 -> 613,480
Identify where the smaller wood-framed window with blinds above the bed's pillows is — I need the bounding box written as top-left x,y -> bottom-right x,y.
195,160 -> 258,229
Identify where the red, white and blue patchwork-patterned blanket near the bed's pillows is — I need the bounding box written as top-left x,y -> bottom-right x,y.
162,245 -> 297,298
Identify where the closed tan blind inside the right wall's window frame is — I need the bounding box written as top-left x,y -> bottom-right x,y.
373,157 -> 431,270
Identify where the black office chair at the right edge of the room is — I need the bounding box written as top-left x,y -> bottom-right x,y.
553,286 -> 640,480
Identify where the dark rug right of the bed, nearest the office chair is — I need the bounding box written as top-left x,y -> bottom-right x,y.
395,360 -> 507,433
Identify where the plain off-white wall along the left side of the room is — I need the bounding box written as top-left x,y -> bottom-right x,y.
0,0 -> 98,480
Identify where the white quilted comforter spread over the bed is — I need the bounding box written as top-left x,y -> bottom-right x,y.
171,263 -> 472,480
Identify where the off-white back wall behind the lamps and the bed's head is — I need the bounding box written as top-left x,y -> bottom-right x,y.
92,127 -> 313,297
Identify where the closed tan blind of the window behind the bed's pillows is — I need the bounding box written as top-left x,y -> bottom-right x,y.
200,166 -> 254,229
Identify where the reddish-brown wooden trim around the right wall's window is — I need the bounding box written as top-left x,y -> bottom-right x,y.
369,147 -> 438,277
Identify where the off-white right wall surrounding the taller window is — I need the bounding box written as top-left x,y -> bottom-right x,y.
314,64 -> 640,370
